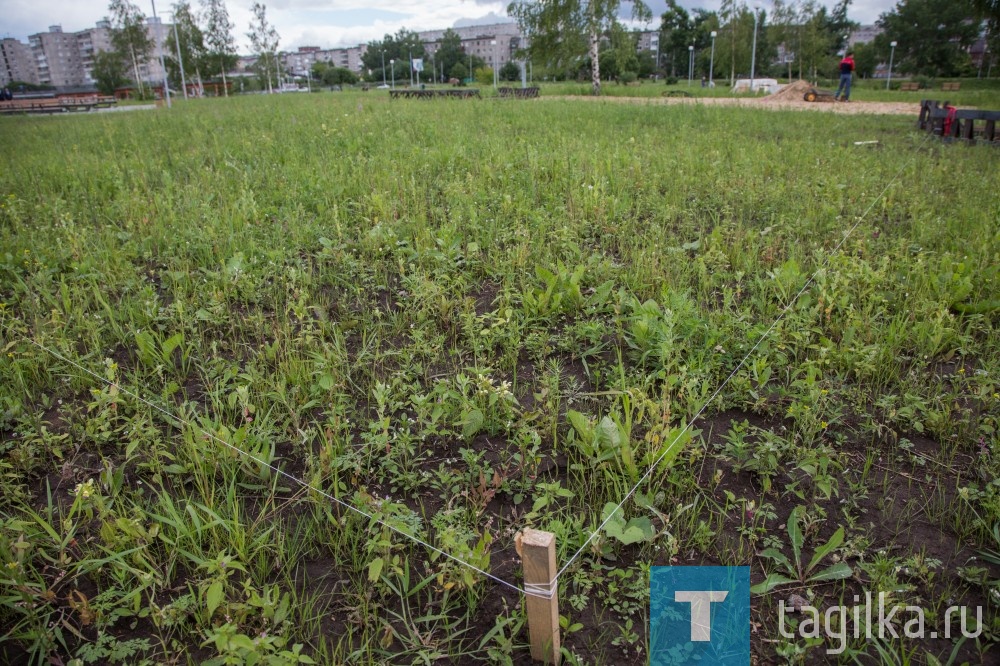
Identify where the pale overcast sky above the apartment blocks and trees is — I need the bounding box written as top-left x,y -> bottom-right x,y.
0,0 -> 895,53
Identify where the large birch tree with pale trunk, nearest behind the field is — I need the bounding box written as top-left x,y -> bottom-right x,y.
507,0 -> 652,95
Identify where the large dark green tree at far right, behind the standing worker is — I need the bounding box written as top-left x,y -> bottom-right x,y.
875,0 -> 979,76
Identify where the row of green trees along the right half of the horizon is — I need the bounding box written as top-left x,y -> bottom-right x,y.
507,0 -> 1000,94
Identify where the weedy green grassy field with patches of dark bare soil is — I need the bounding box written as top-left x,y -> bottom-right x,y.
0,91 -> 1000,664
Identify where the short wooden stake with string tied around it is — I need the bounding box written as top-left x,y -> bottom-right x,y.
515,528 -> 562,666
